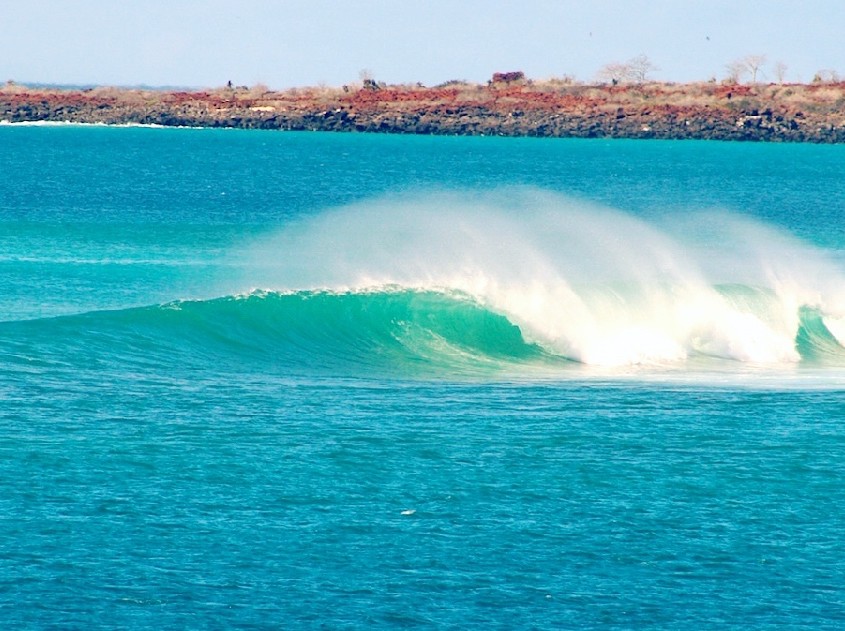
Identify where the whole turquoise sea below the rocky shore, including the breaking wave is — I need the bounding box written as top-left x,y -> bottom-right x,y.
0,126 -> 845,629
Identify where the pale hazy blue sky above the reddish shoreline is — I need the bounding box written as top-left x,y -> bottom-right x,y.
6,0 -> 845,88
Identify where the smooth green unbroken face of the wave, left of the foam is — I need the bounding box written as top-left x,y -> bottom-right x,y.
0,289 -> 554,377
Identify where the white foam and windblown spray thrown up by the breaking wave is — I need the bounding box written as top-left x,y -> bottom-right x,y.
247,189 -> 845,366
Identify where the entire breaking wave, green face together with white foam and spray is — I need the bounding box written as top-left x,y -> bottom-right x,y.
6,190 -> 845,377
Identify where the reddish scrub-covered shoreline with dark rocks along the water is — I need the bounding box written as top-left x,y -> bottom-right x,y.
0,79 -> 845,143
